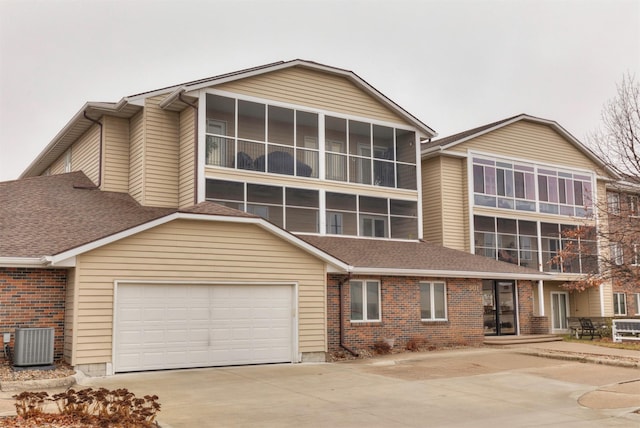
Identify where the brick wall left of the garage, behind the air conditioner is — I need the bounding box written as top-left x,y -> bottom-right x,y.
0,268 -> 67,360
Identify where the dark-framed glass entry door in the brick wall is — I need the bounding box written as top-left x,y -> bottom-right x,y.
482,280 -> 517,336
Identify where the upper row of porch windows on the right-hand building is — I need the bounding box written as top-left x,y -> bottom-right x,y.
473,157 -> 593,217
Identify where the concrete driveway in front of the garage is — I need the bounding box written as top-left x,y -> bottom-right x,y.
81,348 -> 640,428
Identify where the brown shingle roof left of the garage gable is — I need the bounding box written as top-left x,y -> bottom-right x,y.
0,172 -> 175,257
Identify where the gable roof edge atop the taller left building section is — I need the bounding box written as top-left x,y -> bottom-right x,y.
20,59 -> 436,178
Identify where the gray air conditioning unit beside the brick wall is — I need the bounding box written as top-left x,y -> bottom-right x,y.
13,327 -> 54,367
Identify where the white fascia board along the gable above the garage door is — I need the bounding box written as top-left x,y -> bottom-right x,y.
47,213 -> 349,271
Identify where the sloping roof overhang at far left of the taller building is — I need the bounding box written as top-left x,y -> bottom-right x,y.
19,98 -> 142,178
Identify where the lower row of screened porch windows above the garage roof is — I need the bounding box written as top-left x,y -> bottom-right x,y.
206,179 -> 418,240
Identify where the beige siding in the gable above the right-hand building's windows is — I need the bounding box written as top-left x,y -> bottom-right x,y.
452,121 -> 602,173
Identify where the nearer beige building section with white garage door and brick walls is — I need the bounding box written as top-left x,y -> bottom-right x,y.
0,60 -> 549,375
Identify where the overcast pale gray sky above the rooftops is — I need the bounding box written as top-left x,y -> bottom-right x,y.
0,0 -> 640,181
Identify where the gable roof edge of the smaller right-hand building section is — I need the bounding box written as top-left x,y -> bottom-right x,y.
421,113 -> 617,177
